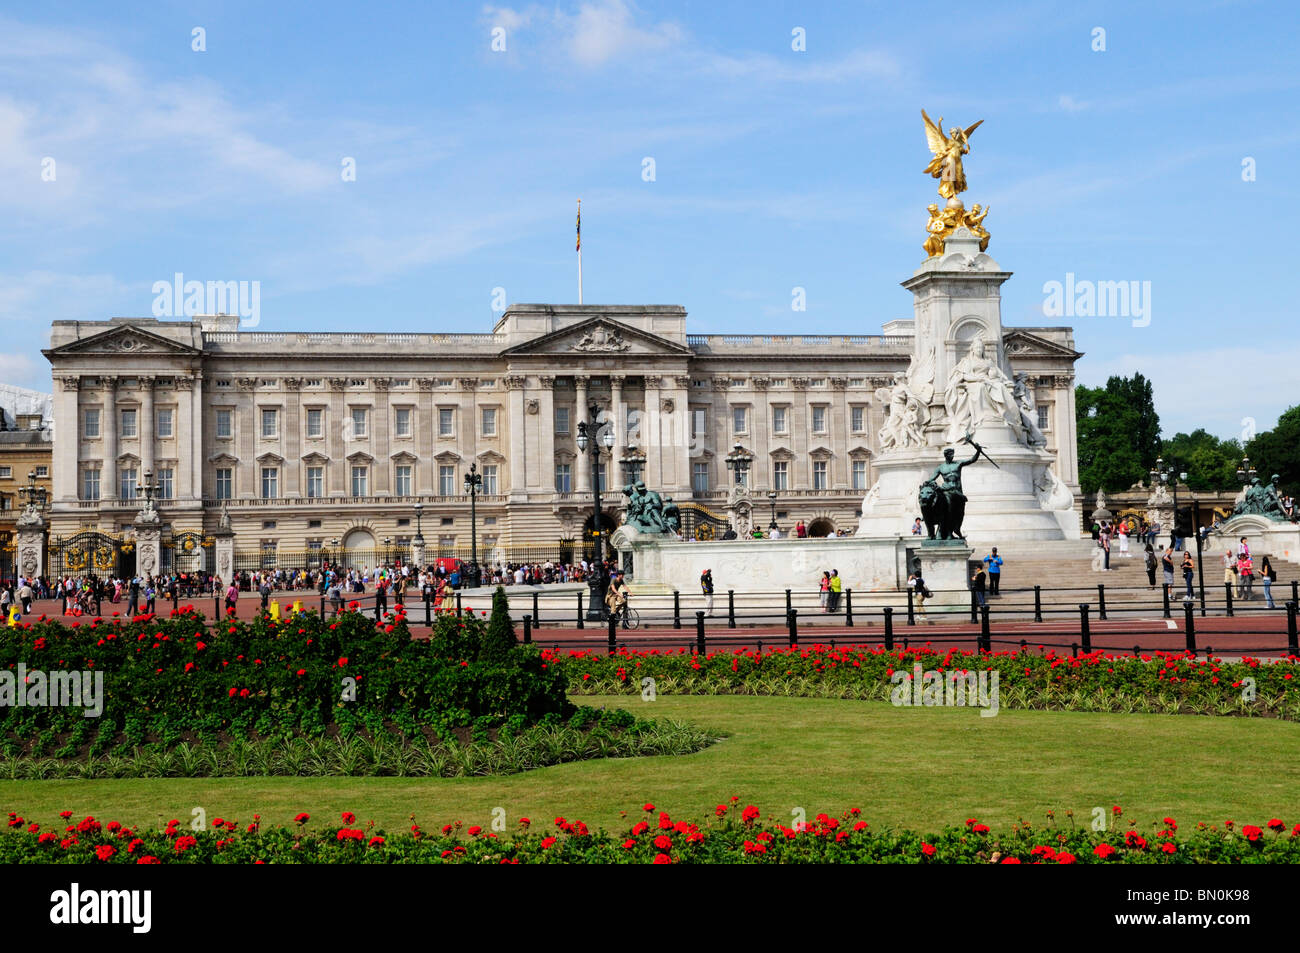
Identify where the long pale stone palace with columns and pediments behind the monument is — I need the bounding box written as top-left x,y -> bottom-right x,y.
46,304 -> 1080,572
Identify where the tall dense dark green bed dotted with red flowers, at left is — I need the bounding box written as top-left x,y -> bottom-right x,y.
0,590 -> 576,758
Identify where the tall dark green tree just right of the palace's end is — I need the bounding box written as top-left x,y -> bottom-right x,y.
1075,373 -> 1161,494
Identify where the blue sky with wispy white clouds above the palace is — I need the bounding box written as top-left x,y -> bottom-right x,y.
0,0 -> 1300,437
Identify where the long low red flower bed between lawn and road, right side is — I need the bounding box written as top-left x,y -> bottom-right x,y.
553,644 -> 1300,720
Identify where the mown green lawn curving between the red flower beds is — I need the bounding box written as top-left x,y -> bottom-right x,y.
0,696 -> 1300,829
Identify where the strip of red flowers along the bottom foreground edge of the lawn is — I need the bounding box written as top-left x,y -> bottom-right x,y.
0,797 -> 1300,863
